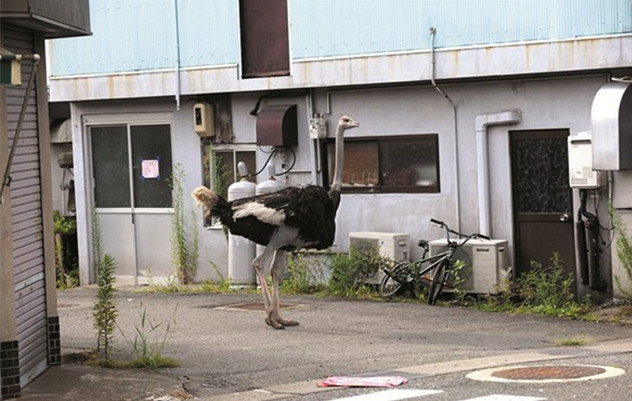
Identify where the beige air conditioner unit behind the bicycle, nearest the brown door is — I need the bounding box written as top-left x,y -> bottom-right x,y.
429,239 -> 512,294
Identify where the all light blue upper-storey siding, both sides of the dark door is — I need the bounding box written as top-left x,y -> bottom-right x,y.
50,0 -> 632,76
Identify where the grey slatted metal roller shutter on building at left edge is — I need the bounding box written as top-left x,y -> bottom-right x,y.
1,26 -> 48,387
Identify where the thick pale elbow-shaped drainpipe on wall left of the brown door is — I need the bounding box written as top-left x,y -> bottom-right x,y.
475,110 -> 522,237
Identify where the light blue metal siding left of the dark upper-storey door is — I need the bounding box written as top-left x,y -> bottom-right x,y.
50,0 -> 239,76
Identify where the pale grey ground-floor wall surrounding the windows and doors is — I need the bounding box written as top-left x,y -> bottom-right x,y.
73,74 -> 632,296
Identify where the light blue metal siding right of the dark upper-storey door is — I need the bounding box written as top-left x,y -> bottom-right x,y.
290,0 -> 632,59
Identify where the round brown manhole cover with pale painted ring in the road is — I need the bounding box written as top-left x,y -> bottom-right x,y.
467,365 -> 625,383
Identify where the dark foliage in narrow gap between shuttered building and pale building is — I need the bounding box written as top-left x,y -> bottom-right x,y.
53,210 -> 79,290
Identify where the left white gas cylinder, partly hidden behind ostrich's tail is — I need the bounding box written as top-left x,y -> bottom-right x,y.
228,162 -> 256,287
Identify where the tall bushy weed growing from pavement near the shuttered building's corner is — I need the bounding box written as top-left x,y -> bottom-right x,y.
92,210 -> 118,365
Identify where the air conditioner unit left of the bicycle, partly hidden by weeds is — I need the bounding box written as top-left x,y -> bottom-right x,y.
349,231 -> 410,284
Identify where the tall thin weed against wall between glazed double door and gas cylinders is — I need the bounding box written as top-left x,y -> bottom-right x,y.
171,164 -> 198,284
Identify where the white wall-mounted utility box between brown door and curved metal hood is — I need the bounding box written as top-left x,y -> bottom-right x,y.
568,131 -> 601,189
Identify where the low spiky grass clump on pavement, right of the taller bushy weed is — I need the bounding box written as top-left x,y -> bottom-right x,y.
117,303 -> 178,369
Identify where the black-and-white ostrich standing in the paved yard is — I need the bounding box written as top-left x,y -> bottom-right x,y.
192,116 -> 360,329
